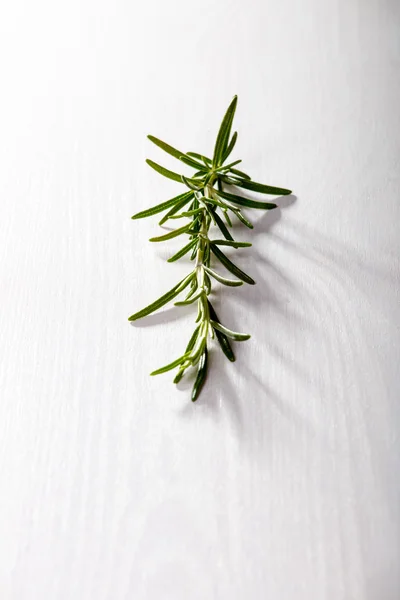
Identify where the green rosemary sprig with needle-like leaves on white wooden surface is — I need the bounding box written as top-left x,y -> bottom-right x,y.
129,96 -> 291,401
